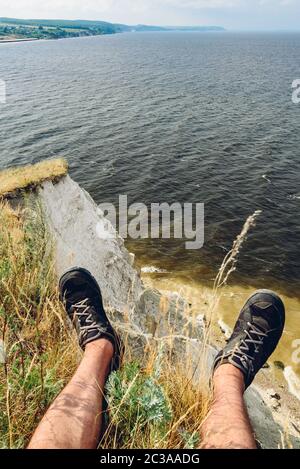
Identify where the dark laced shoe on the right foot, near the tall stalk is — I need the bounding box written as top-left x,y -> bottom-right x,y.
214,290 -> 285,389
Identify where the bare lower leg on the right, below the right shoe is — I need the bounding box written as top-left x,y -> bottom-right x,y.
201,364 -> 257,449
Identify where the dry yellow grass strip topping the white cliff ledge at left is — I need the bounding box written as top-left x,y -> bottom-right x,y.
0,158 -> 68,197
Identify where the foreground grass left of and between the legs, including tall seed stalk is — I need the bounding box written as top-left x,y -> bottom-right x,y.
0,196 -> 260,449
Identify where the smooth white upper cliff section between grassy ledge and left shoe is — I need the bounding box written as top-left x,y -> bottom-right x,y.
39,176 -> 143,311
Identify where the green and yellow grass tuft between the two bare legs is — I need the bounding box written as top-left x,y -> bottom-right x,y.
100,354 -> 210,449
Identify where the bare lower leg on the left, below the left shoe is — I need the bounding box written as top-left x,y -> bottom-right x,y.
28,339 -> 113,449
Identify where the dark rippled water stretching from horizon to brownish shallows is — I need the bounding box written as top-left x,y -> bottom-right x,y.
0,32 -> 300,296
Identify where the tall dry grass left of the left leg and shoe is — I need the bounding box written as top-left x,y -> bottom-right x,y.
0,197 -> 78,448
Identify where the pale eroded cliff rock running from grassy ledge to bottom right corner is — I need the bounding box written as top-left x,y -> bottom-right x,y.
38,176 -> 300,448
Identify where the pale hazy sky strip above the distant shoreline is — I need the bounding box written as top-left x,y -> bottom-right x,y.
0,0 -> 300,30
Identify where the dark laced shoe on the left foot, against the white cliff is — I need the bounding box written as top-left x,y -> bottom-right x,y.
59,267 -> 123,370
